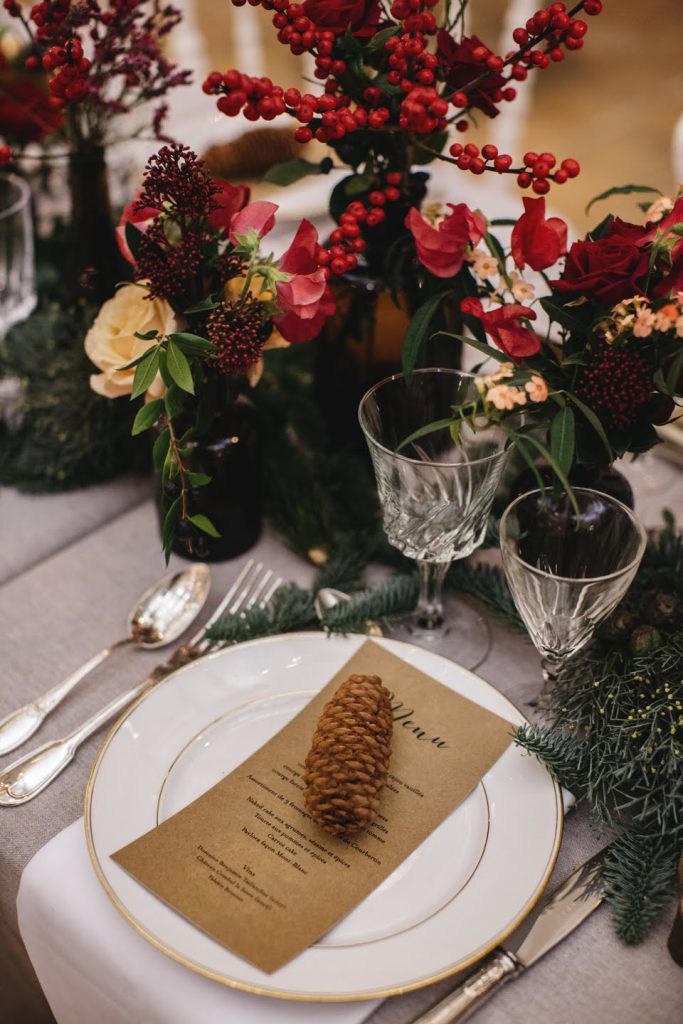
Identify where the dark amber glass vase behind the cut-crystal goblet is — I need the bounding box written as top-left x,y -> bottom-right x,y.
313,269 -> 462,453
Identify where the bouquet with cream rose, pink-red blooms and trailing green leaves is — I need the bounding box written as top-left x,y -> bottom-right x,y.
85,144 -> 334,557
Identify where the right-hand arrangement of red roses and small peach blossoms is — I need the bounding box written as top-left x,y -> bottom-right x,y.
417,186 -> 683,486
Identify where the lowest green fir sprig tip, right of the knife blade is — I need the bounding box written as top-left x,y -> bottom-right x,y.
603,830 -> 681,945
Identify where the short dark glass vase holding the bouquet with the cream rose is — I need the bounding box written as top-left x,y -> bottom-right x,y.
157,402 -> 262,562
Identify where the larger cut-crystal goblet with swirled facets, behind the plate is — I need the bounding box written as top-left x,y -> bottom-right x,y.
358,369 -> 508,668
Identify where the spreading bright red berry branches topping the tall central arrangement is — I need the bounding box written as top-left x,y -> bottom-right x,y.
203,0 -> 602,195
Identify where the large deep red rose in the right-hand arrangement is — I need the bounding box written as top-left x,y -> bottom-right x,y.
550,234 -> 648,306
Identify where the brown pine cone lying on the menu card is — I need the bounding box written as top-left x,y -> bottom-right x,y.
304,676 -> 393,836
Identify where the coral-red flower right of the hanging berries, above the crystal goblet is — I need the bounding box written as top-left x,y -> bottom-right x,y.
405,203 -> 486,278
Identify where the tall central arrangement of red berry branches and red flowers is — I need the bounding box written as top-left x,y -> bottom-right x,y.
203,0 -> 602,352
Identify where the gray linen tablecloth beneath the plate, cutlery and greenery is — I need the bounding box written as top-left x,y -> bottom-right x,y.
0,477 -> 683,1024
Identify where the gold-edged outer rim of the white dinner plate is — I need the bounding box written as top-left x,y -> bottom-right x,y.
83,632 -> 564,1002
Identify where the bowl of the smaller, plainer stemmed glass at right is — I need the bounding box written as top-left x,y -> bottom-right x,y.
501,487 -> 647,684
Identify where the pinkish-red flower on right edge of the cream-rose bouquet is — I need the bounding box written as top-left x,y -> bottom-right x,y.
274,220 -> 335,342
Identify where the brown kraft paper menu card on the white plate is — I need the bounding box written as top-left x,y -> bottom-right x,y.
113,641 -> 511,974
